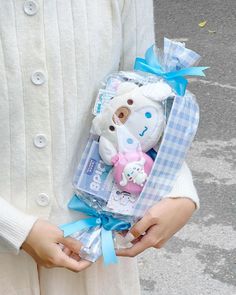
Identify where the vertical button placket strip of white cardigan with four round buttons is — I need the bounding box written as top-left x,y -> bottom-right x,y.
16,0 -> 54,218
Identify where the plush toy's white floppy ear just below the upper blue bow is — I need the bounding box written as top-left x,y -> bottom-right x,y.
140,81 -> 175,101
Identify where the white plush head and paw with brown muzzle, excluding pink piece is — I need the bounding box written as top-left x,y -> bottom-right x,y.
93,81 -> 173,164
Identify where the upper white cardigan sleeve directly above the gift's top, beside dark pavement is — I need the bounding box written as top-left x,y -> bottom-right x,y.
120,0 -> 155,70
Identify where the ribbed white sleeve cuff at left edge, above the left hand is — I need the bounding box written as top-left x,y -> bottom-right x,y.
0,197 -> 37,254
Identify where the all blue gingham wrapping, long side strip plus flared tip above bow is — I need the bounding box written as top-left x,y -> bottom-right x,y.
133,38 -> 200,217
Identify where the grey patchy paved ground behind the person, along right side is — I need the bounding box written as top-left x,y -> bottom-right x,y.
139,0 -> 236,295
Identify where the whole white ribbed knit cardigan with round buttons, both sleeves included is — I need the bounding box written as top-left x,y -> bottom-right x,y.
0,0 -> 198,253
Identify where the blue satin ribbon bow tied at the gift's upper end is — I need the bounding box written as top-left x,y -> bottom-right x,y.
134,45 -> 208,96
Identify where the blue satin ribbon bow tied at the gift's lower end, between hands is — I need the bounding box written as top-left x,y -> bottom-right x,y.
60,195 -> 131,265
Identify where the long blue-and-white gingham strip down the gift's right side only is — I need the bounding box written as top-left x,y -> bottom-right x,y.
133,91 -> 199,217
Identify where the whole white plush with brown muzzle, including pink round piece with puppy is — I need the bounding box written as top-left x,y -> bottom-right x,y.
92,80 -> 175,194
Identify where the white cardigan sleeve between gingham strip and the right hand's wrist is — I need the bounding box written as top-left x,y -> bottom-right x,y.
163,162 -> 200,209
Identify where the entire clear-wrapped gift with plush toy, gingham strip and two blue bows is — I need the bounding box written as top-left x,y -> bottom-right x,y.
60,38 -> 206,264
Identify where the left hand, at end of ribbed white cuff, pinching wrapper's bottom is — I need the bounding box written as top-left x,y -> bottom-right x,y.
21,219 -> 92,272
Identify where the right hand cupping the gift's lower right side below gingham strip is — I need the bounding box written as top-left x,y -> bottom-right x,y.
117,198 -> 195,257
